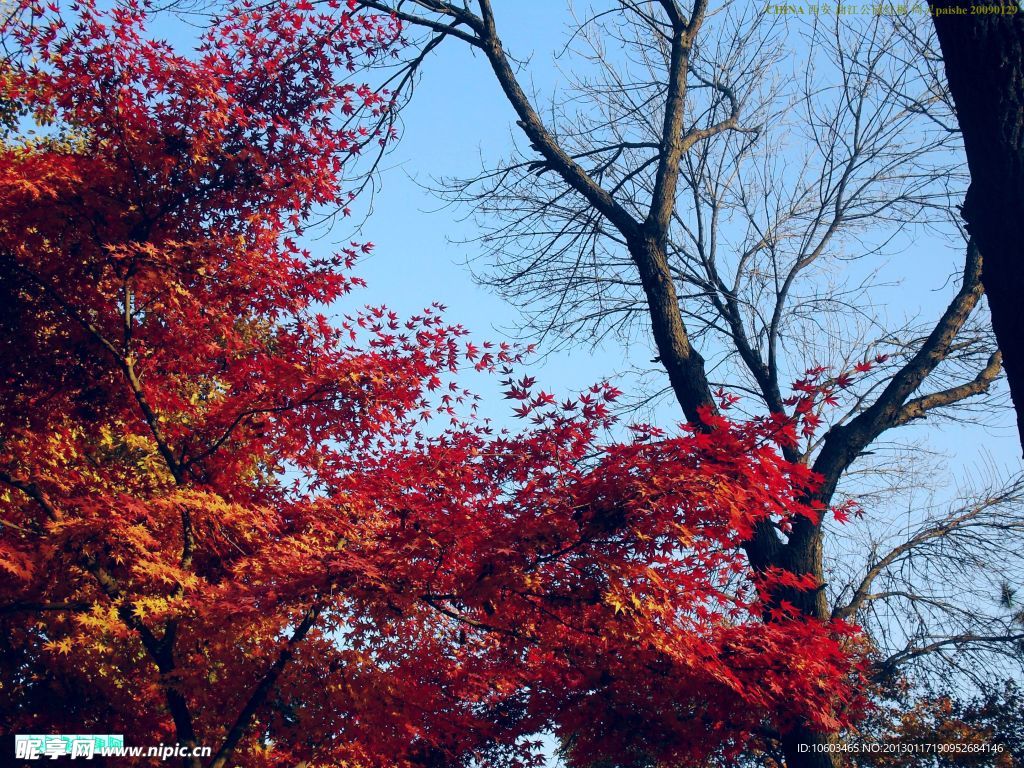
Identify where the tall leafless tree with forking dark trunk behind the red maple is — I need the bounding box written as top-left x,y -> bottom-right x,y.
342,0 -> 1021,766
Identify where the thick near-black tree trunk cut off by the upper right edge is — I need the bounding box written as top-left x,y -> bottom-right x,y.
929,0 -> 1024,454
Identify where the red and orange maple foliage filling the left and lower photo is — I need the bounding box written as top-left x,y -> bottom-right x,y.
0,2 -> 858,767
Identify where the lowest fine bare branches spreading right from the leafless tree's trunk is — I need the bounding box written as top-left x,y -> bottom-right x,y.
833,478 -> 1024,687
